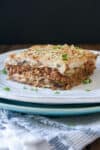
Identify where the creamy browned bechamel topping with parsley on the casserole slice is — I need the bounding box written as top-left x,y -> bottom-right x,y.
6,44 -> 96,74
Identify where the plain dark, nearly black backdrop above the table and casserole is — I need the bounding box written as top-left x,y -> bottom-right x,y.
0,0 -> 100,44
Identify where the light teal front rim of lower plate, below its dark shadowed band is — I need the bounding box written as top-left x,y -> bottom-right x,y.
0,103 -> 100,116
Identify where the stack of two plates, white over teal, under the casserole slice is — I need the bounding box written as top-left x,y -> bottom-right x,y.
0,51 -> 100,116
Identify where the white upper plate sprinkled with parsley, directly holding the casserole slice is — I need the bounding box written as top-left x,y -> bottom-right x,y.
0,49 -> 100,104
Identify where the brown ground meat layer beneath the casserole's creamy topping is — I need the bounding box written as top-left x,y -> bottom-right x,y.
6,61 -> 95,89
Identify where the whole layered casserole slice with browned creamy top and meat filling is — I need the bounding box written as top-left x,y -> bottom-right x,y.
5,44 -> 97,90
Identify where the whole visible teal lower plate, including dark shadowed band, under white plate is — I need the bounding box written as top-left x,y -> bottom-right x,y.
0,99 -> 100,116
